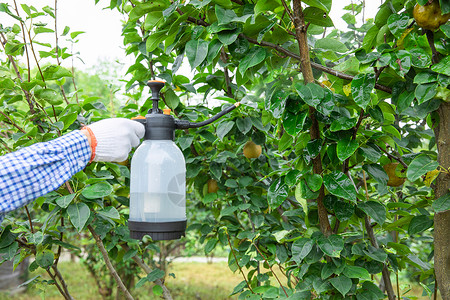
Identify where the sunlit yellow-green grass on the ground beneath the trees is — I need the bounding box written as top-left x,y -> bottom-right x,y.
0,262 -> 442,300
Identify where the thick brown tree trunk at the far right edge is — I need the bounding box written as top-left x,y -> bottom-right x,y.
434,102 -> 450,300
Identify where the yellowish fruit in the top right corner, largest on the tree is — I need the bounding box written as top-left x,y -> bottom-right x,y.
413,0 -> 450,31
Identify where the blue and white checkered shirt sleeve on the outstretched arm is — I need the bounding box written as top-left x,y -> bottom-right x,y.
0,130 -> 91,224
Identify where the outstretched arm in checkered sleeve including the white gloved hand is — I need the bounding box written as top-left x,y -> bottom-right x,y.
0,118 -> 145,223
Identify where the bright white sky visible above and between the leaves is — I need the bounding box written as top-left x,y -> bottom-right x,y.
0,0 -> 381,70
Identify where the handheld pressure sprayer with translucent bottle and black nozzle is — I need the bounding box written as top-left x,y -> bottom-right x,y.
128,80 -> 239,241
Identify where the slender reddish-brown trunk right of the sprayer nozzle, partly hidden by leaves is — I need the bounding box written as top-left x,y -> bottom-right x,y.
293,0 -> 332,236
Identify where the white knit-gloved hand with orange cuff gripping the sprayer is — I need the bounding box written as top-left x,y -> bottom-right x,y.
83,118 -> 145,162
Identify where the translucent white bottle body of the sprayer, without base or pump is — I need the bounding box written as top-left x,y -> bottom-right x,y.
130,140 -> 186,223
